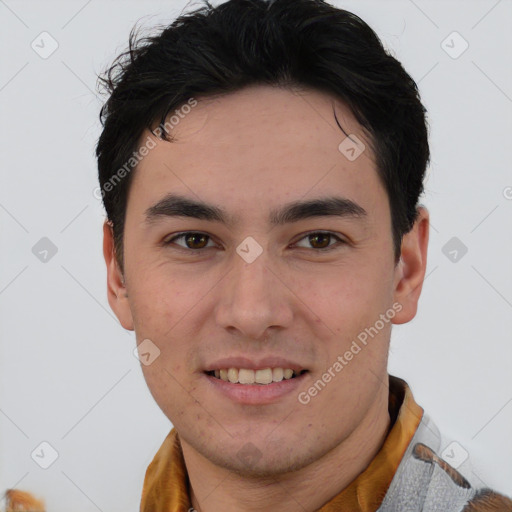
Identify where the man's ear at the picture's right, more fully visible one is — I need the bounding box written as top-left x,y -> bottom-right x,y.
392,206 -> 429,324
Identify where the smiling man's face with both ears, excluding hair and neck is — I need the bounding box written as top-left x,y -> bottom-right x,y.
105,86 -> 426,474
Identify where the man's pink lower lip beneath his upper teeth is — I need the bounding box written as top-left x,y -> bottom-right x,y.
204,372 -> 308,405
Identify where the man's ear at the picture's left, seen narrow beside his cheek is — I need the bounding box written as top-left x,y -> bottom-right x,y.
103,220 -> 134,331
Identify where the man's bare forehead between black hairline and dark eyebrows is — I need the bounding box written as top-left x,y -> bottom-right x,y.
128,86 -> 385,218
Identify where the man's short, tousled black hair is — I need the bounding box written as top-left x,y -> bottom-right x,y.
96,0 -> 430,270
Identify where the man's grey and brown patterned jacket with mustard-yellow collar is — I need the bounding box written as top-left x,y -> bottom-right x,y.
140,376 -> 512,512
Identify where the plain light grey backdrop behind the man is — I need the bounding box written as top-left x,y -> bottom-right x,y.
0,0 -> 512,512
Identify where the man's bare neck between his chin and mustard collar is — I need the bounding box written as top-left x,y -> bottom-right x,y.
181,386 -> 390,512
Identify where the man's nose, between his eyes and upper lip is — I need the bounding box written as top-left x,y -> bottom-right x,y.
215,253 -> 293,341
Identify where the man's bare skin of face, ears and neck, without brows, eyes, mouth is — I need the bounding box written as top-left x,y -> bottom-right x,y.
104,86 -> 429,512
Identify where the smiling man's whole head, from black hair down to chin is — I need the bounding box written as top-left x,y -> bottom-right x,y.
97,0 -> 429,474
